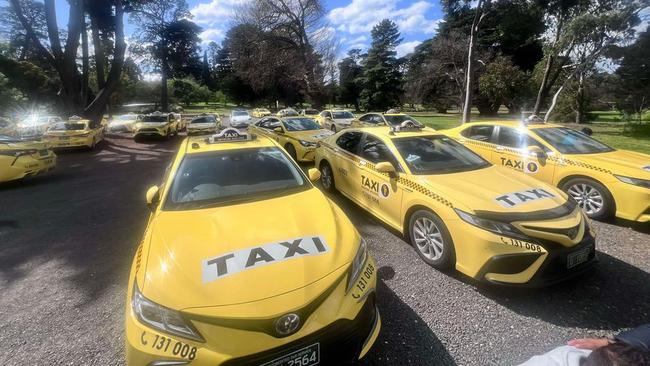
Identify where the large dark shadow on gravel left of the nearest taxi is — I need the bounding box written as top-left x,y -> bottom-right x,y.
0,139 -> 180,305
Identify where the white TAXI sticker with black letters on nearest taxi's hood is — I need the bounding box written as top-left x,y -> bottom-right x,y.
202,236 -> 329,283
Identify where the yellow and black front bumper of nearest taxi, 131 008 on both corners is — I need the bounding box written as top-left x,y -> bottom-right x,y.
126,257 -> 381,366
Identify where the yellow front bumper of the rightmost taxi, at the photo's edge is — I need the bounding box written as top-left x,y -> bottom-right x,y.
607,181 -> 650,222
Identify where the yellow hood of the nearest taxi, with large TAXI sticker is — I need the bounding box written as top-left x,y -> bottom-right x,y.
142,188 -> 360,309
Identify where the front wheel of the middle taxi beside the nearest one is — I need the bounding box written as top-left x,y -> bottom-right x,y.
408,210 -> 456,270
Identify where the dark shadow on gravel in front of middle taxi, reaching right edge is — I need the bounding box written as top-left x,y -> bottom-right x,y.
479,252 -> 650,330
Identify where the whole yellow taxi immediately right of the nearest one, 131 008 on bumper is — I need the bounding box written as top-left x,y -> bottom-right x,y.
315,127 -> 596,286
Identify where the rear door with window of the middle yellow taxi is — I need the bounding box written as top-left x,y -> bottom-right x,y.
330,131 -> 363,194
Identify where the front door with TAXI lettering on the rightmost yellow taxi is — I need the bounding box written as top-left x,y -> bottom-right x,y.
491,126 -> 556,183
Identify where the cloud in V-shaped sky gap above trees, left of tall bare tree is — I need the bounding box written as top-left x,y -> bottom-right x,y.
190,0 -> 250,43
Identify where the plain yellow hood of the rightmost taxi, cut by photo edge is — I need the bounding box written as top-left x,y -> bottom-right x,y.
565,150 -> 650,179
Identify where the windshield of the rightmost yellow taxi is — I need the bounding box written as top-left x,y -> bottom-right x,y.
533,127 -> 614,154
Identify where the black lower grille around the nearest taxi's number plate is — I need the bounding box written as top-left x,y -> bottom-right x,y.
223,294 -> 377,366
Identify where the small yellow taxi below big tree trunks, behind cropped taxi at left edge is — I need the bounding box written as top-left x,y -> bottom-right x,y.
42,116 -> 104,150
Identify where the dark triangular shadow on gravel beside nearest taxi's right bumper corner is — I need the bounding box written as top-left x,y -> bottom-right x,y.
359,267 -> 456,365
